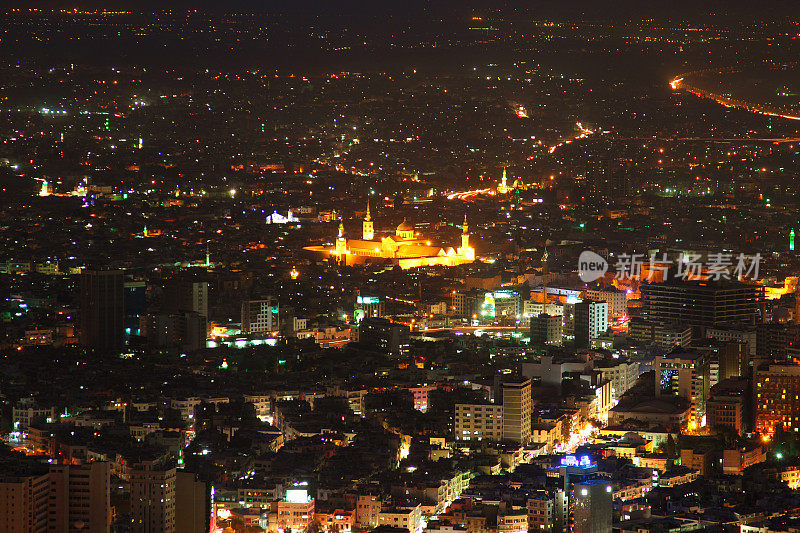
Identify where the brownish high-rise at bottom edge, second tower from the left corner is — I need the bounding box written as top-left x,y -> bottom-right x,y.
48,461 -> 111,533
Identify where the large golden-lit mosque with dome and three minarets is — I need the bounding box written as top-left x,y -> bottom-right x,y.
304,204 -> 475,270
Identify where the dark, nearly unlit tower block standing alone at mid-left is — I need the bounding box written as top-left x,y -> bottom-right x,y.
80,270 -> 125,351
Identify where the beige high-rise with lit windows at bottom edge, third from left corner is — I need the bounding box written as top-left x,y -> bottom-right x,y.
130,461 -> 176,533
